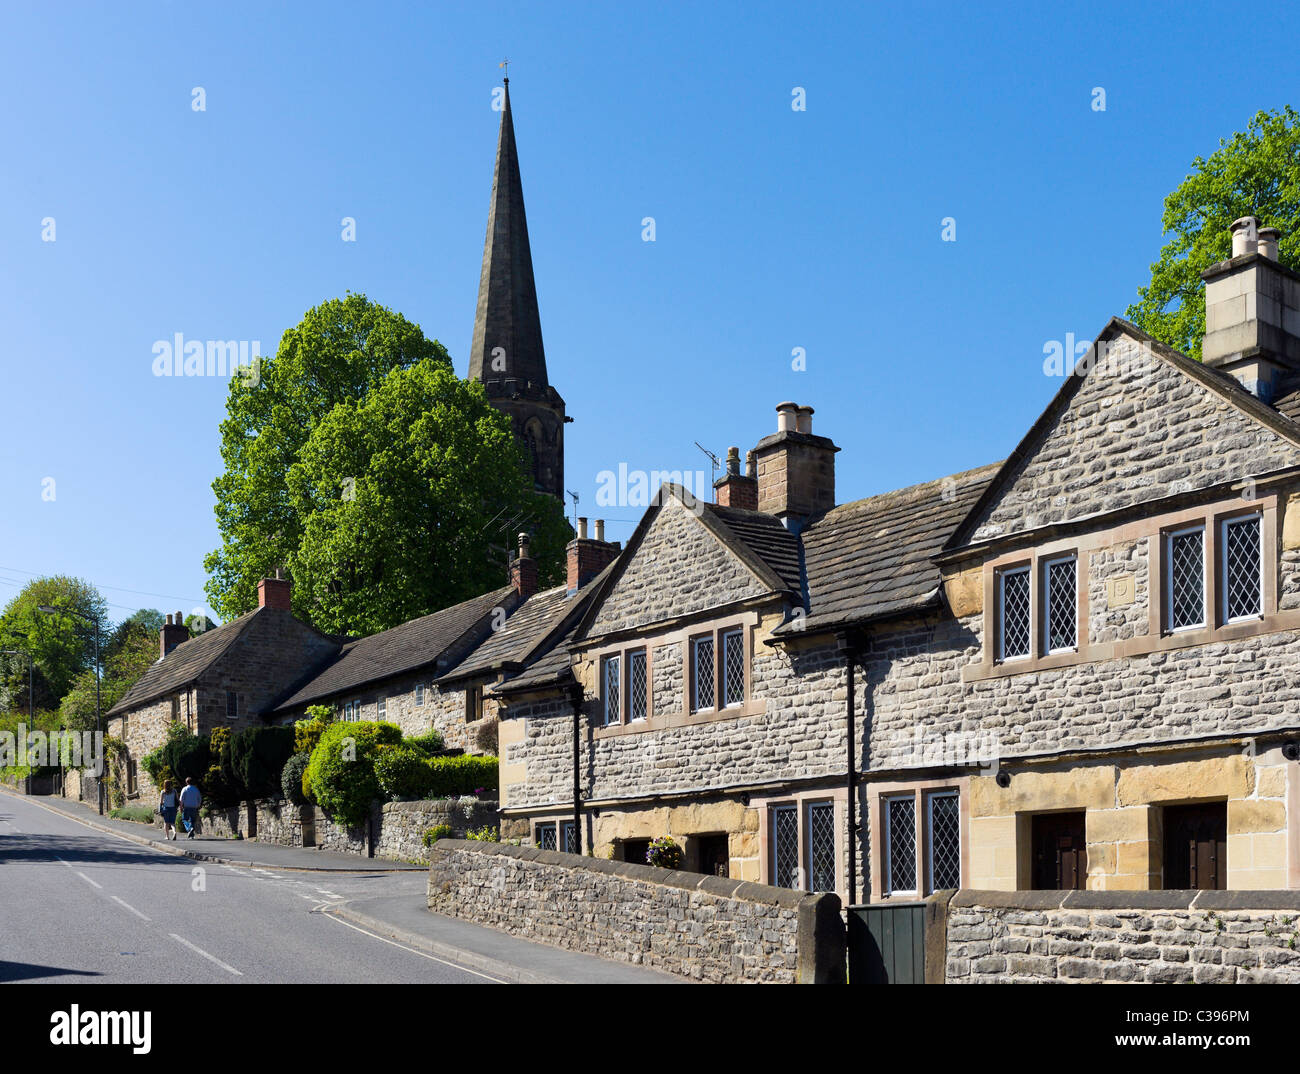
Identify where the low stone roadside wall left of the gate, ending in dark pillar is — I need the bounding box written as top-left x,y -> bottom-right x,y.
429,840 -> 845,983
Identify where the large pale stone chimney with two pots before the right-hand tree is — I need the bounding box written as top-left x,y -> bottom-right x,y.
1201,216 -> 1300,403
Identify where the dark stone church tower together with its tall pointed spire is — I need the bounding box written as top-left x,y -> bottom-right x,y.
469,78 -> 572,502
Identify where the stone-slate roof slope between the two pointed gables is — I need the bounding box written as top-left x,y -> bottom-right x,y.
776,463 -> 1001,635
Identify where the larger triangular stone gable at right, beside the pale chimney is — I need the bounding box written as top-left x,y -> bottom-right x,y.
971,338 -> 1300,541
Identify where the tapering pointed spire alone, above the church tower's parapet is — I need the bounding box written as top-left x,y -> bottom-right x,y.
469,78 -> 547,395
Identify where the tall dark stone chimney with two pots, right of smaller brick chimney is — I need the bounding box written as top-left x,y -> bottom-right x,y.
751,403 -> 840,532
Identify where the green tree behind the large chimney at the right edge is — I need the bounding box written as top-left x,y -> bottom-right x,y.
1128,105 -> 1300,359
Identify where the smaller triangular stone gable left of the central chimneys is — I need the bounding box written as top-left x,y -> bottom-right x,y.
589,497 -> 768,636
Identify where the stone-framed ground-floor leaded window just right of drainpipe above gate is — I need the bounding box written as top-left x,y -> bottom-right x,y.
867,778 -> 970,900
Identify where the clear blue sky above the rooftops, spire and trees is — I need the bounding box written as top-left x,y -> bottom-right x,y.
0,3 -> 1300,616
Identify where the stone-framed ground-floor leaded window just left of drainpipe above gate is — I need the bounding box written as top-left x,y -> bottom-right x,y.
751,788 -> 849,892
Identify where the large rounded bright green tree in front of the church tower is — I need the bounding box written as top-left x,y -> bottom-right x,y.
205,294 -> 568,633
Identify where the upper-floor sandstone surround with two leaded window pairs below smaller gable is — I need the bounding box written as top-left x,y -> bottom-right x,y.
582,611 -> 767,739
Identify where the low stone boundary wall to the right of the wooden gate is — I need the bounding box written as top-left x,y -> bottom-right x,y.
945,891 -> 1300,984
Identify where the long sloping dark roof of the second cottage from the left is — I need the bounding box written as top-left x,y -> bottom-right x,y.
272,585 -> 514,713
